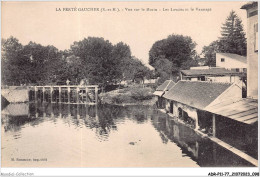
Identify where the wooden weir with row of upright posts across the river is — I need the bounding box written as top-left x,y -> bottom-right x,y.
28,85 -> 98,104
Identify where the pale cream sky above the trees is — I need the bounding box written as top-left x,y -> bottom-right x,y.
1,1 -> 247,64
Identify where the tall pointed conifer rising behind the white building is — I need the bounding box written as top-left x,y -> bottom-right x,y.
219,10 -> 246,56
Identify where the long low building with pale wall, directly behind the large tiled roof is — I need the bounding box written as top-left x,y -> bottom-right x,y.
180,67 -> 243,87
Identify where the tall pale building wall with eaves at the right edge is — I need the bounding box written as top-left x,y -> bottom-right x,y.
241,2 -> 258,99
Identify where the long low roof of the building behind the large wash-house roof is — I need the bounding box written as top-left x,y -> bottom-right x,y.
181,68 -> 239,76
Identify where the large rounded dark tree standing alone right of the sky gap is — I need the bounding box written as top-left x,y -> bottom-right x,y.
149,35 -> 197,80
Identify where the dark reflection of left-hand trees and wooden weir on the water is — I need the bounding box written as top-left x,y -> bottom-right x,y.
2,103 -> 152,141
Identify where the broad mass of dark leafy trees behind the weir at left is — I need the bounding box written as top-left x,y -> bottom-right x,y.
1,37 -> 152,86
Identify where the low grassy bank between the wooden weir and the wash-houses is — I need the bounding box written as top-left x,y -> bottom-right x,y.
100,85 -> 155,105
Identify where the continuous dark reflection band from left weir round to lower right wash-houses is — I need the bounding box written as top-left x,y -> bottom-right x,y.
1,103 -> 252,167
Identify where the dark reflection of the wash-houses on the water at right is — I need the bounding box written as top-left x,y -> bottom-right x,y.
152,111 -> 253,167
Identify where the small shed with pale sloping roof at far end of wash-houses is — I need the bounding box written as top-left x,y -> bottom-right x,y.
153,80 -> 176,109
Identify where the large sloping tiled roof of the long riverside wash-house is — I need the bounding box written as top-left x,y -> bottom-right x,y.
163,81 -> 231,109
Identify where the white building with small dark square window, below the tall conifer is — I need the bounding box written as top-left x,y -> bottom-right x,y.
216,53 -> 247,72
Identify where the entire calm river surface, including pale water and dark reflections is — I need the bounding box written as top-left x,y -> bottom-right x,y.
1,103 -> 254,167
